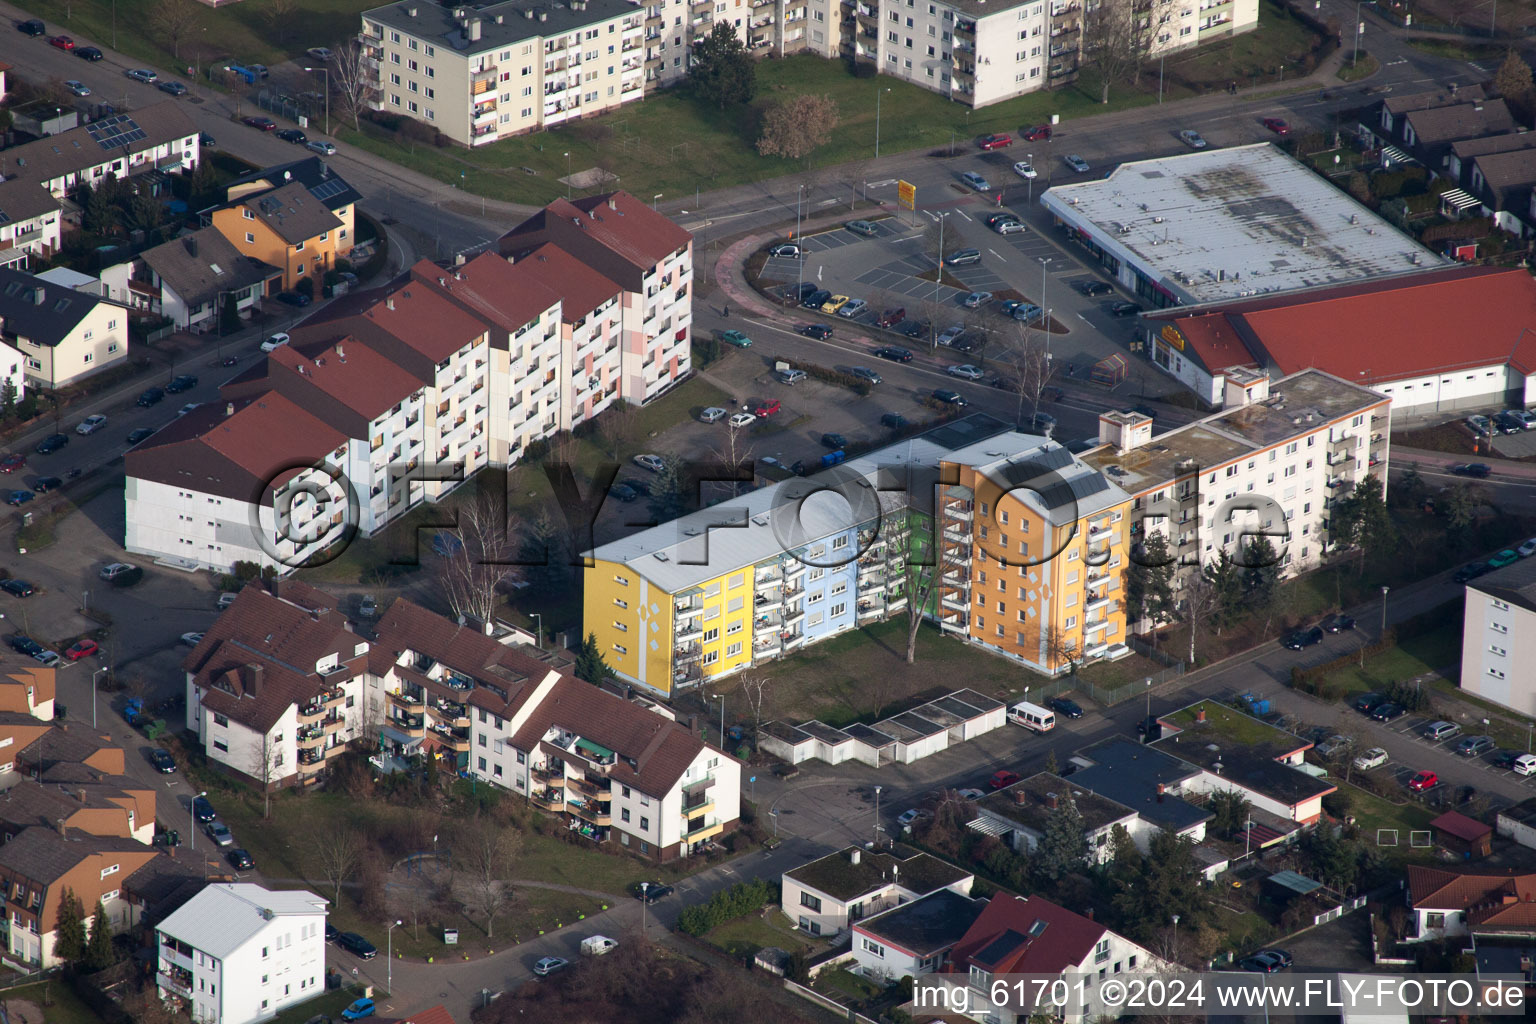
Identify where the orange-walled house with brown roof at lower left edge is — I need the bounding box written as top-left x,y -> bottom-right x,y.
0,826 -> 166,969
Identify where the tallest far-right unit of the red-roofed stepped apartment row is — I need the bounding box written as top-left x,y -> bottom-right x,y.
496,192 -> 693,408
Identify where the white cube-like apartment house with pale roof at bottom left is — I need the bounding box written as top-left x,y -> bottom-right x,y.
155,883 -> 326,1024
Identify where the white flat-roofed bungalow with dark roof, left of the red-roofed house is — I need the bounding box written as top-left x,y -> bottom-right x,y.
779,844 -> 975,936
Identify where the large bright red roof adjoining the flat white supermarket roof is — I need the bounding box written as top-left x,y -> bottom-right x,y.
1150,267 -> 1536,385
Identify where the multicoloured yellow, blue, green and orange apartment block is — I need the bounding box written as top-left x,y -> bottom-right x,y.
584,428 -> 1130,694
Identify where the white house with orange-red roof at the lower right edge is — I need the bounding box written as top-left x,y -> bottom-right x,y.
1405,864 -> 1536,941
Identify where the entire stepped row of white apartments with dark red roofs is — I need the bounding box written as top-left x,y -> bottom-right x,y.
125,191 -> 693,571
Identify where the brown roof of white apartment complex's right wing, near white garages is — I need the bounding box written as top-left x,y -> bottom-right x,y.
511,676 -> 712,797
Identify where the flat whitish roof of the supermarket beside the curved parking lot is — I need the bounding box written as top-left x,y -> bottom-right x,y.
1040,143 -> 1450,306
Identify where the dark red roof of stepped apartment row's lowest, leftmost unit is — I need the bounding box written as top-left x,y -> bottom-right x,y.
124,391 -> 347,504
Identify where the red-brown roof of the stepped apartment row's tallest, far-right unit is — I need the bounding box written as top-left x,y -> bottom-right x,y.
498,192 -> 693,292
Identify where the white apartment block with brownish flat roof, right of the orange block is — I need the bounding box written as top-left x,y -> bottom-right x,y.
1081,370 -> 1392,574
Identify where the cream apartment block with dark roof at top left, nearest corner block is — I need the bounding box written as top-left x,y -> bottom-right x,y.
361,0 -> 645,146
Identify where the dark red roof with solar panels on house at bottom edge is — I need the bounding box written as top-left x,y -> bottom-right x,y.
952,892 -> 1109,975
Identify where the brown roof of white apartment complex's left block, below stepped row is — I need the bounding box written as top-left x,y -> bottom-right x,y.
181,583 -> 367,734
